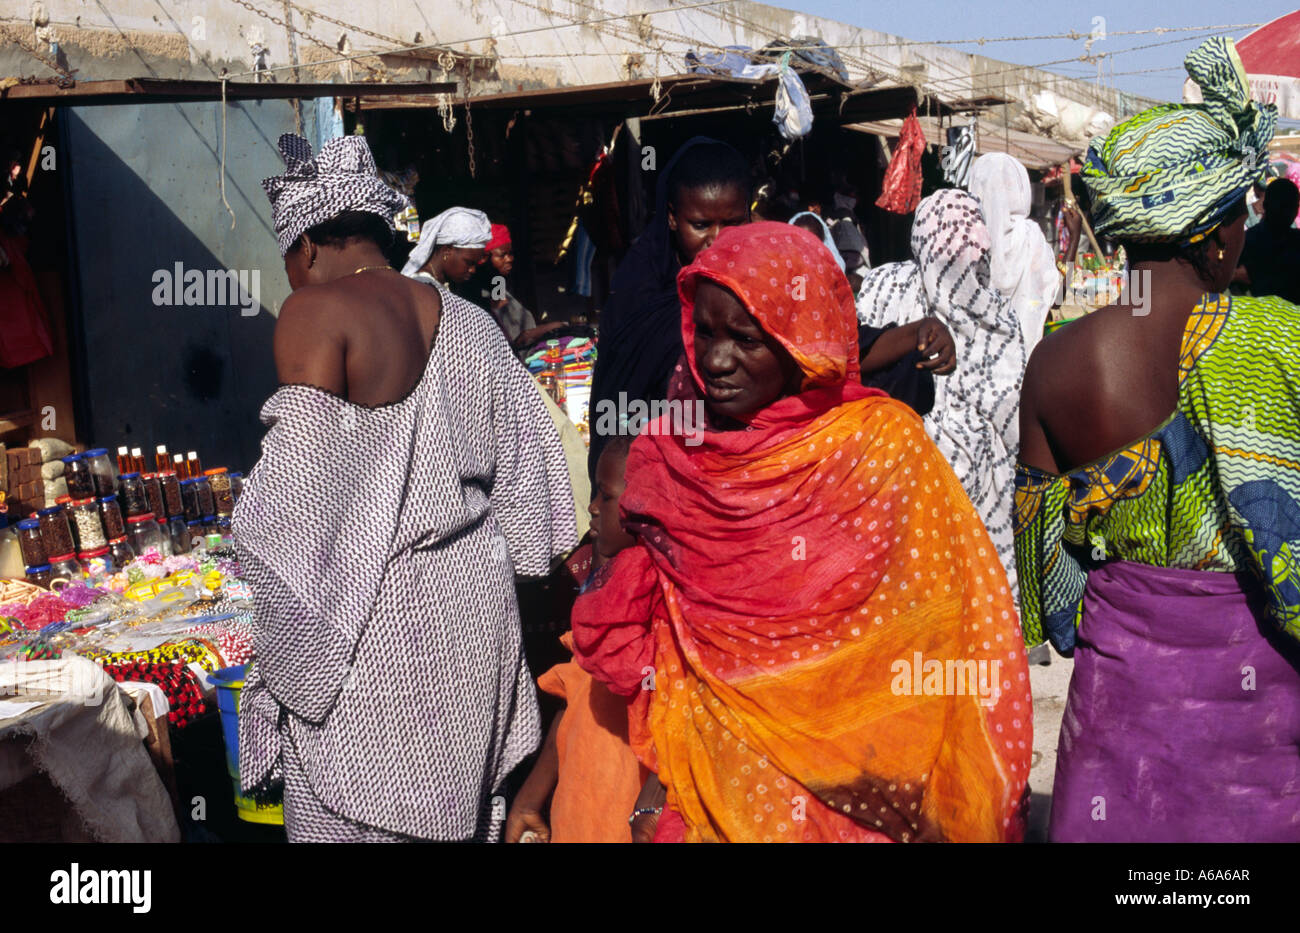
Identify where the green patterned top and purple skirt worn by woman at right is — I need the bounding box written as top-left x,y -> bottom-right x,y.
1015,295 -> 1300,842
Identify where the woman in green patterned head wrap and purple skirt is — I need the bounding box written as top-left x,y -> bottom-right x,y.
1014,38 -> 1300,842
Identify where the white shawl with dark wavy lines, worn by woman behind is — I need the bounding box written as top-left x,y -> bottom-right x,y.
858,190 -> 1028,602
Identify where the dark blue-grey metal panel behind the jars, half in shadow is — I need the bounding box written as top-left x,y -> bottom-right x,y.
60,92 -> 330,470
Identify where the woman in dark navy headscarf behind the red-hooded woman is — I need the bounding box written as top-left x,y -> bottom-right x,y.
588,136 -> 751,476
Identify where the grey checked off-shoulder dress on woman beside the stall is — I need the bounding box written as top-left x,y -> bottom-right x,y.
234,292 -> 577,839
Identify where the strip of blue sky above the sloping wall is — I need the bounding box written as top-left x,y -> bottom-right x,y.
795,0 -> 1295,111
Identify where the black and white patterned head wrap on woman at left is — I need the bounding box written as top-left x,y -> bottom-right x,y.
261,133 -> 411,256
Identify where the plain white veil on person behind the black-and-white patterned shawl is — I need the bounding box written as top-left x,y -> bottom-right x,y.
970,152 -> 1061,353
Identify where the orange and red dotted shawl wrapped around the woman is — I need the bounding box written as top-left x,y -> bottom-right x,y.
573,224 -> 1032,842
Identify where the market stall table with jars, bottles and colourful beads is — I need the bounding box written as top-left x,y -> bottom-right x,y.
0,442 -> 268,841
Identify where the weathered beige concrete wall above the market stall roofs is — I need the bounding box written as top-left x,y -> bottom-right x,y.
0,0 -> 1147,142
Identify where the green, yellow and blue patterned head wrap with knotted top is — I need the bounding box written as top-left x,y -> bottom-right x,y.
1083,36 -> 1278,243
